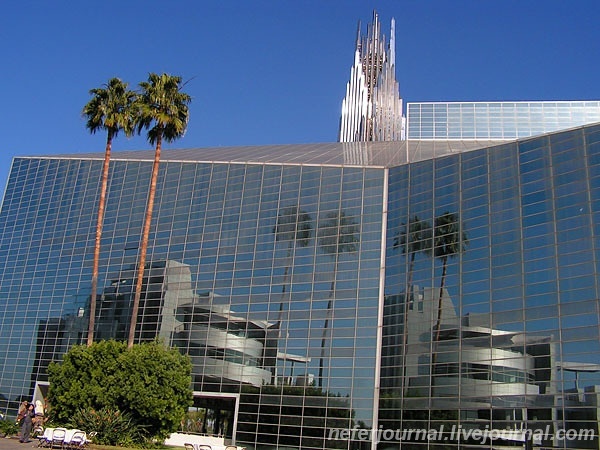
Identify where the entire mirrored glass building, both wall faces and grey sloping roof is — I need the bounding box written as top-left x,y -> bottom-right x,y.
0,125 -> 600,450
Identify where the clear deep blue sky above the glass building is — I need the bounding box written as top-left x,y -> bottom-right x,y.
0,0 -> 600,193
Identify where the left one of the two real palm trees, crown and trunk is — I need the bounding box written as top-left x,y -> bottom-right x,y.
82,78 -> 135,347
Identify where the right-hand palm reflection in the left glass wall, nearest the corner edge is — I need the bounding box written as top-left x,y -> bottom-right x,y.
318,211 -> 359,387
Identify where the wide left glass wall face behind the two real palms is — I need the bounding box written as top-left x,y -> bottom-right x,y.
0,155 -> 385,449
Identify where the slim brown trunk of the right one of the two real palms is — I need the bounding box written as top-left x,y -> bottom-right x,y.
127,133 -> 162,348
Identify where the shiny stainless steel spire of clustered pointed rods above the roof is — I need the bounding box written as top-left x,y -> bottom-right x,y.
339,11 -> 404,142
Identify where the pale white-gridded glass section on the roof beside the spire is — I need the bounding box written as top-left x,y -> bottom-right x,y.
407,101 -> 600,140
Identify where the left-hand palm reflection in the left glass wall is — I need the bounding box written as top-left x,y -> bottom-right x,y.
273,206 -> 313,330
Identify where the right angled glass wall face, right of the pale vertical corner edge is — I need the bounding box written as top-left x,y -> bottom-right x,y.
378,121 -> 600,449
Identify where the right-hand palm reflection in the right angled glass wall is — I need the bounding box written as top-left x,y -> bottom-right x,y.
433,211 -> 469,344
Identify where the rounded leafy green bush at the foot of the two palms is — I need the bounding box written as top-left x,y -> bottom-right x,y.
48,340 -> 193,439
